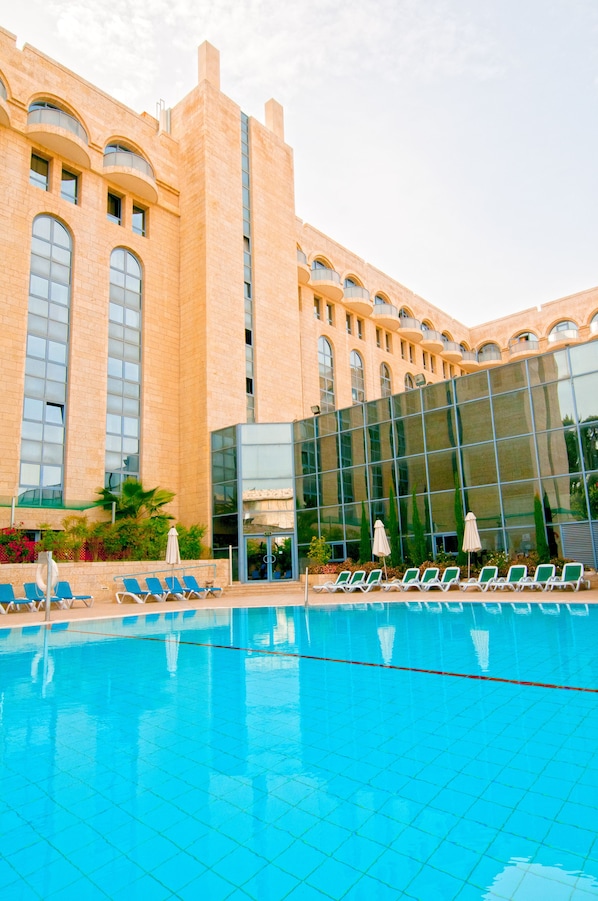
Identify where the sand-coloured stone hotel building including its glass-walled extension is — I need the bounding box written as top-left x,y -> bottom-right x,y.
0,30 -> 598,580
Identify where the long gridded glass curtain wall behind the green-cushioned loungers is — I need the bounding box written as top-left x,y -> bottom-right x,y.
293,343 -> 598,566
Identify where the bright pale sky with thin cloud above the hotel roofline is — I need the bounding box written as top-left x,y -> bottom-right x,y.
0,0 -> 598,325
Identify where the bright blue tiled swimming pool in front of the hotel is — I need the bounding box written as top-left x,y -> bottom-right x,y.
0,603 -> 598,901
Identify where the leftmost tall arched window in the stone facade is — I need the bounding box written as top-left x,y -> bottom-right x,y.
19,216 -> 72,506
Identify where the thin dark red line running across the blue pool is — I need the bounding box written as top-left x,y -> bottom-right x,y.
69,629 -> 598,694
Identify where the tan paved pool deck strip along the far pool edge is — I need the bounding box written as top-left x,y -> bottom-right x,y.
0,582 -> 598,628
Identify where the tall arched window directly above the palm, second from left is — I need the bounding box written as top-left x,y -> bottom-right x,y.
105,247 -> 142,491
